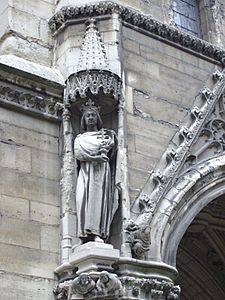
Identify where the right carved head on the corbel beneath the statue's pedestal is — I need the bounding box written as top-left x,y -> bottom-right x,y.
96,271 -> 122,295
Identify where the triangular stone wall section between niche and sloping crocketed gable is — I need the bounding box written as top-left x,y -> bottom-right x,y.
122,26 -> 216,204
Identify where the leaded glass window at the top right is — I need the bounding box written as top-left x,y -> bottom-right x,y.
172,0 -> 201,37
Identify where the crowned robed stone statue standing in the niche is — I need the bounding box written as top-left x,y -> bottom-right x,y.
74,99 -> 117,242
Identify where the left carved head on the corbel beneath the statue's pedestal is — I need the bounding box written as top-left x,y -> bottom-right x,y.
68,273 -> 95,299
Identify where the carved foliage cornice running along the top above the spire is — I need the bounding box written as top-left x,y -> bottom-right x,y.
49,1 -> 225,65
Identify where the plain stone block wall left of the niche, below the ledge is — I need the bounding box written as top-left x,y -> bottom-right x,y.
0,108 -> 60,300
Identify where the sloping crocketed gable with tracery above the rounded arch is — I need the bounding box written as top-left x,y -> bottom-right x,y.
129,71 -> 225,258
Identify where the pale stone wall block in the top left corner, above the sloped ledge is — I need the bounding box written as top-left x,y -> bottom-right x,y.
0,0 -> 55,66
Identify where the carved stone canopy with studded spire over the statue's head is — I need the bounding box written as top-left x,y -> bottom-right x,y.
65,18 -> 121,103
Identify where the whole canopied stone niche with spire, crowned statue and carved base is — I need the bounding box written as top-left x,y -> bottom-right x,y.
54,12 -> 179,300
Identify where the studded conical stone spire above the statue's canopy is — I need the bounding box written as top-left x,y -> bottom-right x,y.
78,18 -> 110,72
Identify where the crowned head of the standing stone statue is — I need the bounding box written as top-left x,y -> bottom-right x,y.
81,99 -> 102,132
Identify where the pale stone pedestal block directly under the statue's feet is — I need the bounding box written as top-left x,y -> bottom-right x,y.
69,242 -> 120,275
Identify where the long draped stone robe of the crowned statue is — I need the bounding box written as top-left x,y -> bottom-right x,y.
74,129 -> 116,239
